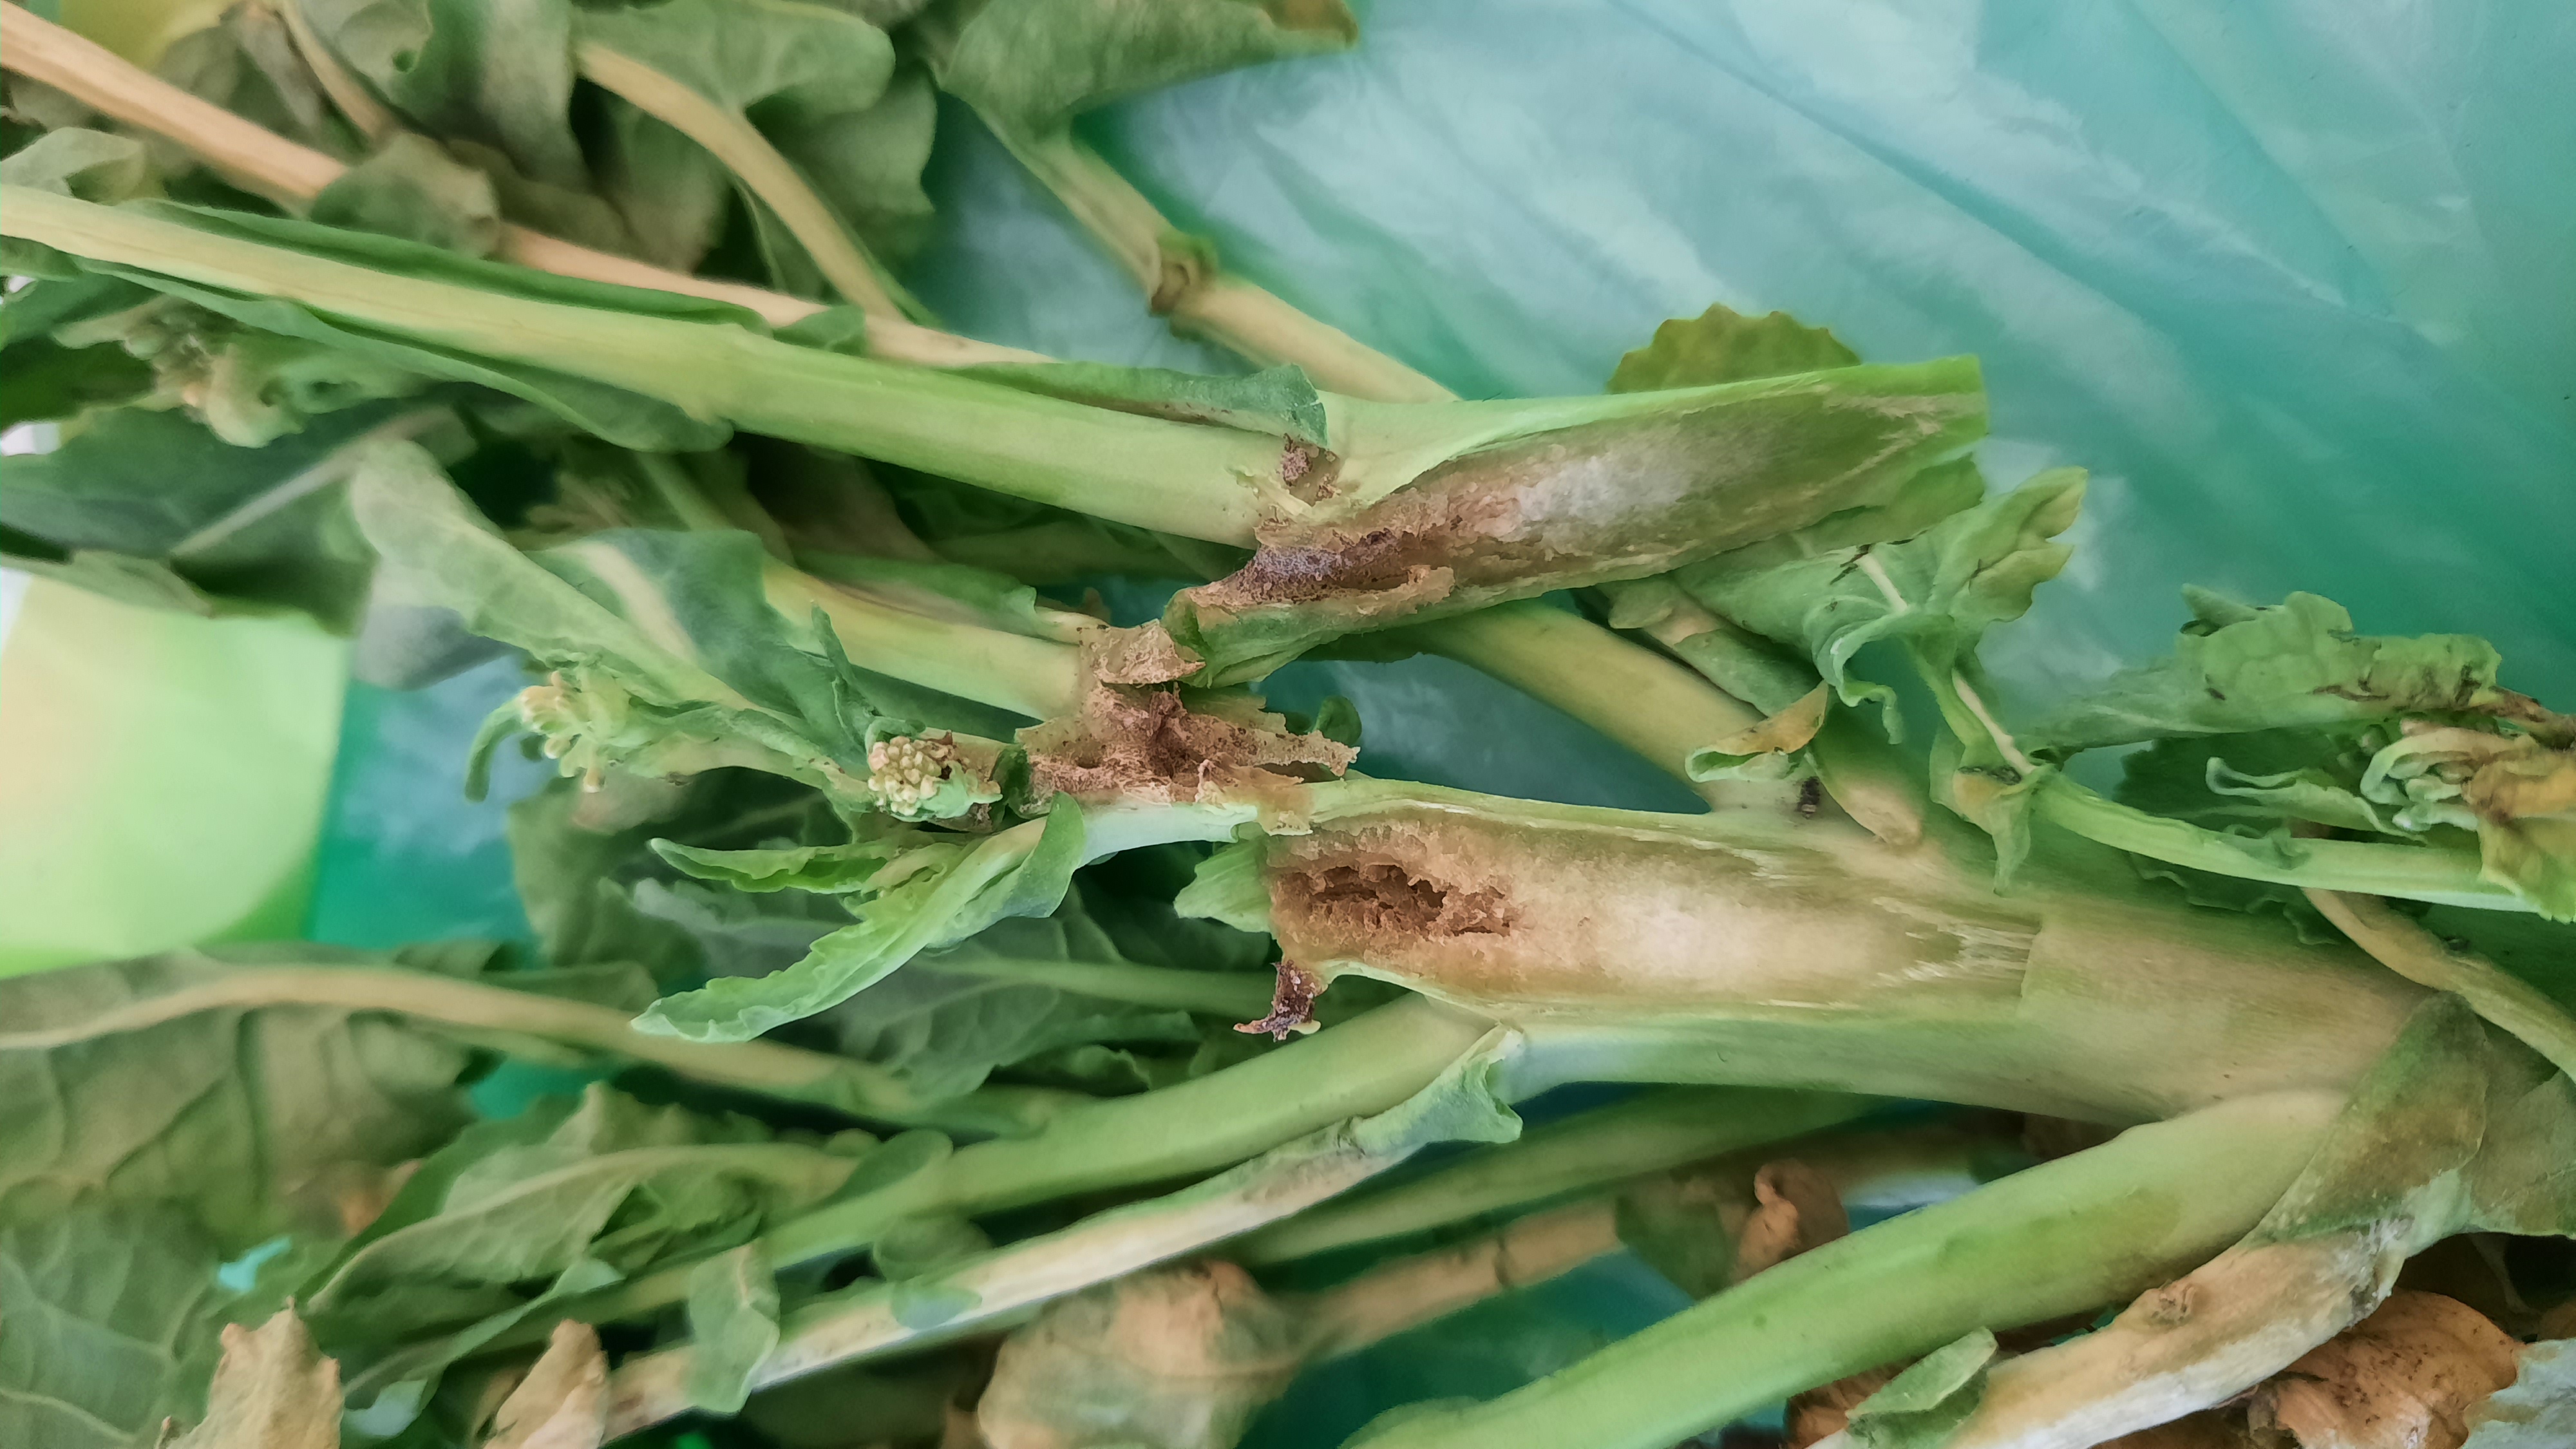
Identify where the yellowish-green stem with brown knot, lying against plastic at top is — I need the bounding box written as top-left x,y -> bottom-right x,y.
984,116 -> 1453,402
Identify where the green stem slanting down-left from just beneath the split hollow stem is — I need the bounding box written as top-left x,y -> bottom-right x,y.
523,998 -> 1489,1343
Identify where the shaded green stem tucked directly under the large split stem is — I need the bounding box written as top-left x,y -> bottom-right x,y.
1226,1088 -> 1880,1266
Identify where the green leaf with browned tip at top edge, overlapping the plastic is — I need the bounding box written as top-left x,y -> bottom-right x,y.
922,0 -> 1360,131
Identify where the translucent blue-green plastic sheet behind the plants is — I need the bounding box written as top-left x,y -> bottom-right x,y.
312,0 -> 2576,1449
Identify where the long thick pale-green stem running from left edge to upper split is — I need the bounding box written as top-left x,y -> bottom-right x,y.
0,185 -> 1280,544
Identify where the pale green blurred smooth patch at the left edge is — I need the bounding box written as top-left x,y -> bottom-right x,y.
0,580 -> 348,974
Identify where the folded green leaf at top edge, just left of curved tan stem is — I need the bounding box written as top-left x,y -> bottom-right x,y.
294,0 -> 587,185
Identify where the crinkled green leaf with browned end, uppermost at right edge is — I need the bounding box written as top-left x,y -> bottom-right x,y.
2020,588 -> 2545,758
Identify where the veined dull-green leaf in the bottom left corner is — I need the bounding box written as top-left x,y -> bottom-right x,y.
0,1201 -> 229,1449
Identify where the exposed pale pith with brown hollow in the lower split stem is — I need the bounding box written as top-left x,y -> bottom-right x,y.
1262,807 -> 2035,1013
